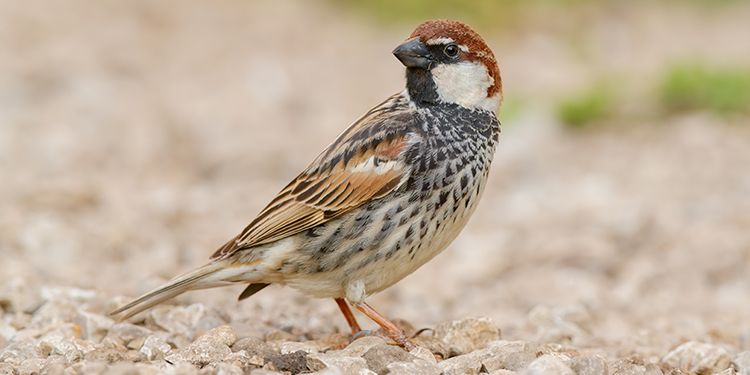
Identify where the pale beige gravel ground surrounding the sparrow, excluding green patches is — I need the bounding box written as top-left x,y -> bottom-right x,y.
0,0 -> 750,374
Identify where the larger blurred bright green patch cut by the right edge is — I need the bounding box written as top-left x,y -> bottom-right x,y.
659,64 -> 750,115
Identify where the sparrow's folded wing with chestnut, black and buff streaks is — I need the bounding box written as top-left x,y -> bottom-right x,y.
211,95 -> 421,259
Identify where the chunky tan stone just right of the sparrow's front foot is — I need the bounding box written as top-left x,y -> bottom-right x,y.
435,318 -> 500,356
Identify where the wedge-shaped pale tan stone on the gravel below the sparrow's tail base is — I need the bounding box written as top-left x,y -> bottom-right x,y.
166,326 -> 237,367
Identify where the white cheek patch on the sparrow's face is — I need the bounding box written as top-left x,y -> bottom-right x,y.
432,61 -> 500,112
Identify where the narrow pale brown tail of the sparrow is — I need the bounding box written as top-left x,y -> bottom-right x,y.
110,260 -> 253,320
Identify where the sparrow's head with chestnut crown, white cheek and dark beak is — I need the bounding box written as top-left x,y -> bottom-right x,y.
393,20 -> 502,111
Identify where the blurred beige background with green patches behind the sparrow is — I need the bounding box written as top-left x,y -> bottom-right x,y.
0,0 -> 750,355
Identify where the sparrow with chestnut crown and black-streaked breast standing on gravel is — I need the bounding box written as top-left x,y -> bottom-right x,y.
111,19 -> 502,350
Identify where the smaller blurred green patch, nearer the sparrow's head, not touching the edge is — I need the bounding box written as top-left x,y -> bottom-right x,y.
557,83 -> 615,129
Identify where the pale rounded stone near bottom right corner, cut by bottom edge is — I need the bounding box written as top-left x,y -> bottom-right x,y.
662,341 -> 732,373
